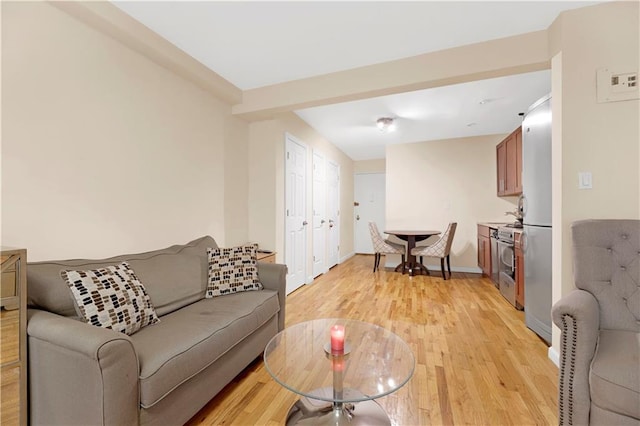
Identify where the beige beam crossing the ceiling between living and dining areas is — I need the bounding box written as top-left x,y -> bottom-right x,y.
233,30 -> 550,120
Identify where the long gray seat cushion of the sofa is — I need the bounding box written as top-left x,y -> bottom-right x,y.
131,290 -> 280,408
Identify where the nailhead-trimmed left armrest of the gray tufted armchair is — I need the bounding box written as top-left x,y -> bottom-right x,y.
551,290 -> 600,425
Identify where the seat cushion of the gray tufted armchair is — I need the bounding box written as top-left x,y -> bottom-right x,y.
589,330 -> 640,419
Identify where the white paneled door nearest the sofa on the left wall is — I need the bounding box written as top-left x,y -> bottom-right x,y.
285,135 -> 307,294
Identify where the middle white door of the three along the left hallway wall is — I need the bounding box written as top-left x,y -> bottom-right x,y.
312,150 -> 327,277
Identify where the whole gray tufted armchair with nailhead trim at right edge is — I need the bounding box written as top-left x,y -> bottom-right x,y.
552,220 -> 640,426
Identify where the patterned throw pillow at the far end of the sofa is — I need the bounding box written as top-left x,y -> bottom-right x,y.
206,244 -> 262,299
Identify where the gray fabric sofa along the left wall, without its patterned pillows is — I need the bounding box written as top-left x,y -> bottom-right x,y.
27,237 -> 286,425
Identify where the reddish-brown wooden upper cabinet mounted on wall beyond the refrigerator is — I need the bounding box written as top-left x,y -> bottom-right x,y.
496,127 -> 522,197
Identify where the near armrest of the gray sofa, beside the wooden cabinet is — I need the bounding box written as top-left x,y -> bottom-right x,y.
27,309 -> 139,425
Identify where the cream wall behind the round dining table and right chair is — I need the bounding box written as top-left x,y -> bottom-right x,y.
387,135 -> 516,272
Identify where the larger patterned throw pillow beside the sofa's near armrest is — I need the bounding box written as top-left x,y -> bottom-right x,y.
61,262 -> 160,335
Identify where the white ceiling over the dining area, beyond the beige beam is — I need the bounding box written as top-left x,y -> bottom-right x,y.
296,70 -> 551,160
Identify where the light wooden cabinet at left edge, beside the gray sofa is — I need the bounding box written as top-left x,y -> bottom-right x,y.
0,248 -> 27,426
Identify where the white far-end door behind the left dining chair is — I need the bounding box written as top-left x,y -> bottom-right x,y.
353,173 -> 386,254
